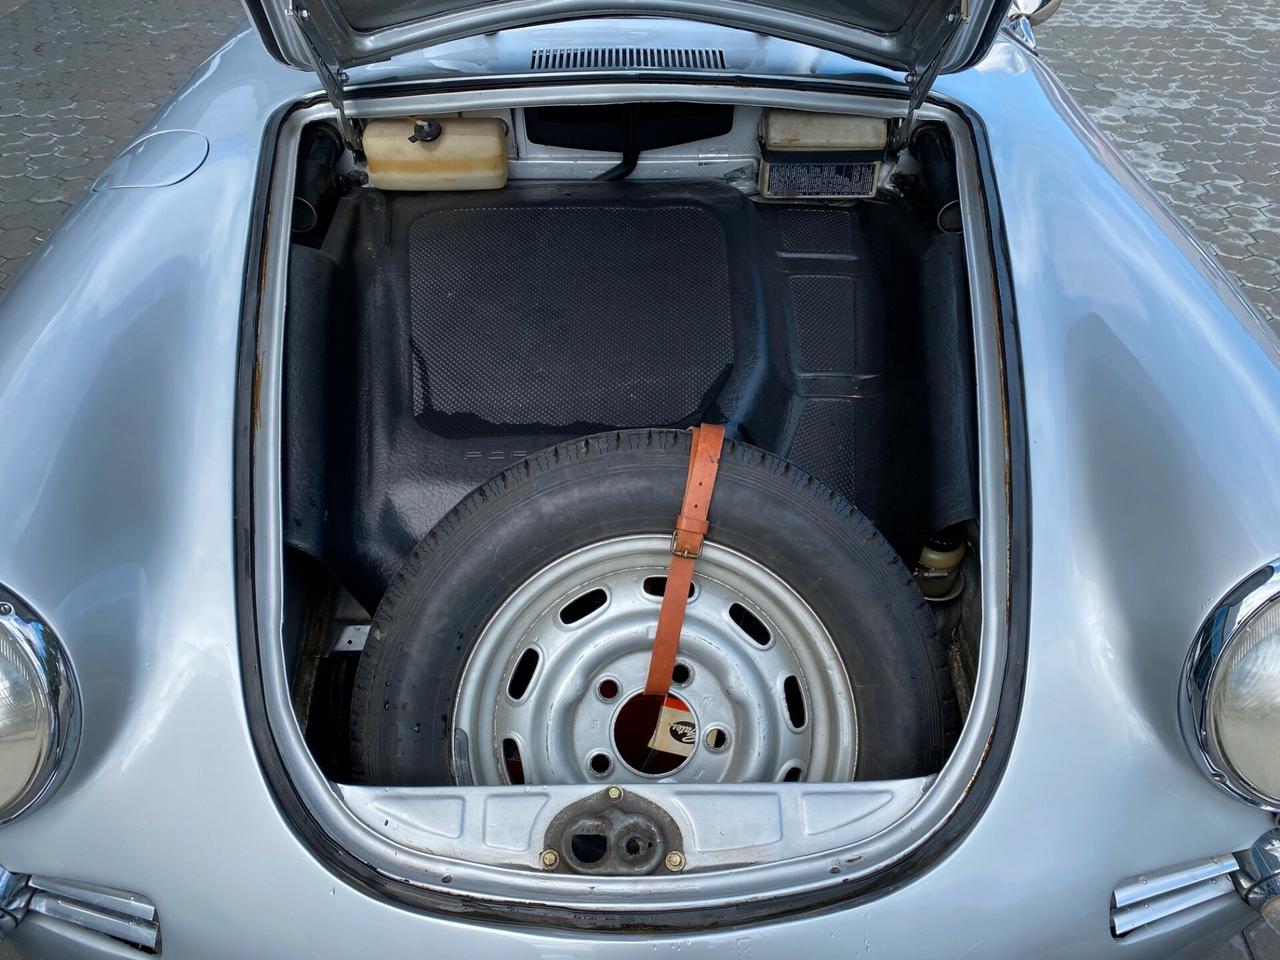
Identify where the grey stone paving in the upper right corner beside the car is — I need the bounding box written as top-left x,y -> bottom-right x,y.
1036,0 -> 1280,329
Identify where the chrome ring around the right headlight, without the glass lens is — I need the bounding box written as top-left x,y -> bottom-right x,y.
1179,559 -> 1280,813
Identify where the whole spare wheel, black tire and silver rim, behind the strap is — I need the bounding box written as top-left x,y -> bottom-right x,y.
351,430 -> 957,786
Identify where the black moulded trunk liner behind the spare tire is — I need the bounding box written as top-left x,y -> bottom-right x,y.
285,180 -> 974,608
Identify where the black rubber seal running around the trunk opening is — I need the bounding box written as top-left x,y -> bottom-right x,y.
233,77 -> 1032,934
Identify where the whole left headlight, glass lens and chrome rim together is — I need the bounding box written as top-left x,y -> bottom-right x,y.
0,598 -> 79,823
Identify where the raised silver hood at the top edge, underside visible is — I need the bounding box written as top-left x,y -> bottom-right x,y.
244,0 -> 1009,87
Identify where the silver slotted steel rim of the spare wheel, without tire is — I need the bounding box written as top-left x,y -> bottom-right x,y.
452,534 -> 858,786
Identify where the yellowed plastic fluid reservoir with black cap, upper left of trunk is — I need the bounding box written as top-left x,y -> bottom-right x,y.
362,116 -> 507,191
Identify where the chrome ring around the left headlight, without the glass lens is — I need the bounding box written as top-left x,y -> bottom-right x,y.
0,589 -> 81,826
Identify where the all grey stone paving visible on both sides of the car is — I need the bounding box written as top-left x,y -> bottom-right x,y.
0,0 -> 1280,960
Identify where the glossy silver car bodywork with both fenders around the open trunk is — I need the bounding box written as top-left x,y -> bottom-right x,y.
0,16 -> 1280,960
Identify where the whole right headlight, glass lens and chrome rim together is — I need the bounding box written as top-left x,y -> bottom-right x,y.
1181,561 -> 1280,810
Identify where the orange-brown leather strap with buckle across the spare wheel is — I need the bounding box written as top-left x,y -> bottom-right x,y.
644,424 -> 724,696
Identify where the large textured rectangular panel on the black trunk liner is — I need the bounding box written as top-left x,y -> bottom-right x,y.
408,197 -> 733,435
